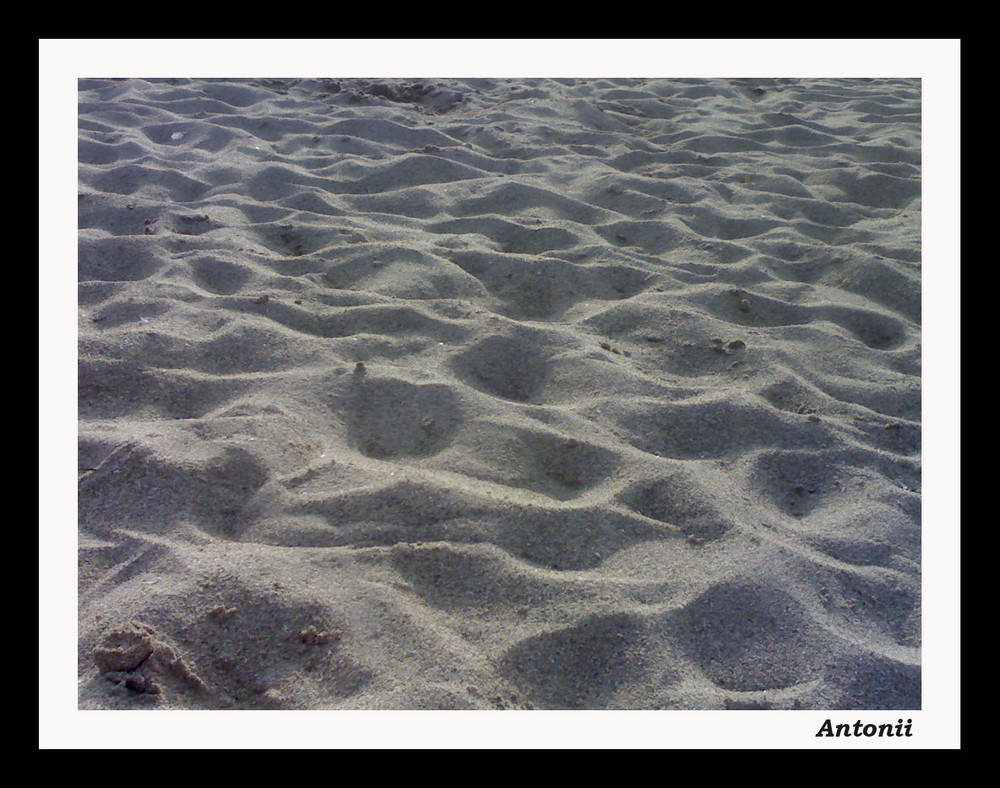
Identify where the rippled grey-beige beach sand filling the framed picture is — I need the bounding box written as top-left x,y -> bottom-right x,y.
77,78 -> 922,722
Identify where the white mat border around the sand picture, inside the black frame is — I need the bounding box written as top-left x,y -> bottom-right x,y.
39,39 -> 960,749
